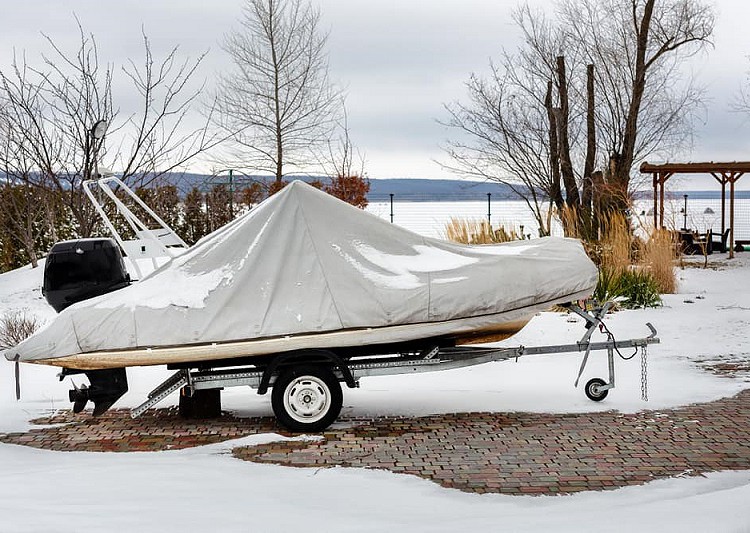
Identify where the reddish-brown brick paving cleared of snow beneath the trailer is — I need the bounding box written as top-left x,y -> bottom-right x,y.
0,390 -> 750,494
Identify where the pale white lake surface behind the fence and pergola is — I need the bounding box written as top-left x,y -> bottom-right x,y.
367,198 -> 750,239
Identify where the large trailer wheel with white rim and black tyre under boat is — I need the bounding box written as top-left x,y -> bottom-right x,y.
271,365 -> 343,432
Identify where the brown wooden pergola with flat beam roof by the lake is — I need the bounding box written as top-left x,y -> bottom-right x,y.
641,161 -> 750,258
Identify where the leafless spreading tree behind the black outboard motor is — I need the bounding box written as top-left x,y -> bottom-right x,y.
0,23 -> 222,236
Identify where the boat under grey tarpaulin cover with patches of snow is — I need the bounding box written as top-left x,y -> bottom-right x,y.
5,181 -> 597,369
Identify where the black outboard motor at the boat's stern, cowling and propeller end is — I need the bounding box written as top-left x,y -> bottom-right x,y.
42,238 -> 130,416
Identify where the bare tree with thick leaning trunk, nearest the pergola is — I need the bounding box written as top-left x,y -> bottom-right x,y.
559,0 -> 714,207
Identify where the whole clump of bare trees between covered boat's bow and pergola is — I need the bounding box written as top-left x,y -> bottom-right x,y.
447,0 -> 713,233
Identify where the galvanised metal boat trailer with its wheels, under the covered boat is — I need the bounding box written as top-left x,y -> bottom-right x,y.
131,302 -> 659,431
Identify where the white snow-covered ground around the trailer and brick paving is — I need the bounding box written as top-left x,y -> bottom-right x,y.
0,254 -> 750,532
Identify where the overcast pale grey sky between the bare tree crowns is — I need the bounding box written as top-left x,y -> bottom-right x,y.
0,0 -> 750,188
